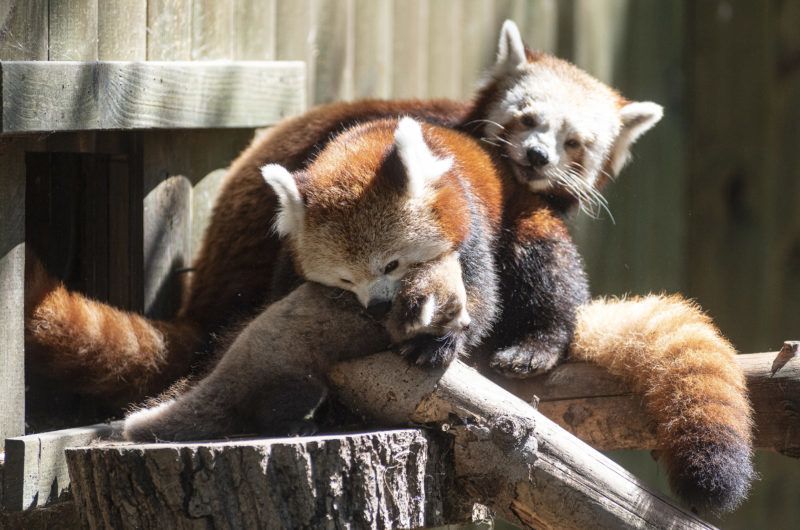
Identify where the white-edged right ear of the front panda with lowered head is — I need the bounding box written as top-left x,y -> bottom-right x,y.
394,118 -> 453,197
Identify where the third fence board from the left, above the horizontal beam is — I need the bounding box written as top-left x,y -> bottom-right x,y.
97,0 -> 147,61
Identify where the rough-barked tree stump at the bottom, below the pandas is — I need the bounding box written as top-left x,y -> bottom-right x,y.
67,430 -> 448,529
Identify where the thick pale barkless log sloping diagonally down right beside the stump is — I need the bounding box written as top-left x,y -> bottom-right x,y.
330,353 -> 710,529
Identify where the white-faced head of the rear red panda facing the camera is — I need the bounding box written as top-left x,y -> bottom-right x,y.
476,20 -> 663,216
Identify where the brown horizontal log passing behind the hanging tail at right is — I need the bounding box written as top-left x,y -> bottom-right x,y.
492,343 -> 800,457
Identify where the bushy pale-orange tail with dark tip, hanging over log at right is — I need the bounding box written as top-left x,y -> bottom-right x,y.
571,295 -> 755,512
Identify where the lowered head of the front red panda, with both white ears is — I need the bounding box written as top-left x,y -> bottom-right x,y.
261,118 -> 469,306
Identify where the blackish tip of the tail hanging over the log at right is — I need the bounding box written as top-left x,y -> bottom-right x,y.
669,434 -> 758,515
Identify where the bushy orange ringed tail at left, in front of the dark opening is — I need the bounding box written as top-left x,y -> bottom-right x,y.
25,260 -> 203,403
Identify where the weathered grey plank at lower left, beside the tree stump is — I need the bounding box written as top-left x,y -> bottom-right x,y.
3,422 -> 122,511
